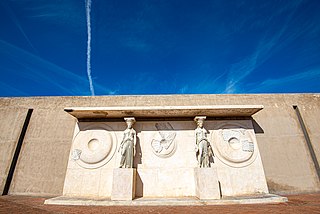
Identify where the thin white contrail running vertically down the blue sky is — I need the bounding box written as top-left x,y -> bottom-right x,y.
86,0 -> 94,96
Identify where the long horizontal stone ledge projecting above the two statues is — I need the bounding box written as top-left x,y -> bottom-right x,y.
64,105 -> 263,119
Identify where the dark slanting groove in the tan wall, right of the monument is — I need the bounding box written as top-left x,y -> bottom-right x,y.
293,105 -> 320,181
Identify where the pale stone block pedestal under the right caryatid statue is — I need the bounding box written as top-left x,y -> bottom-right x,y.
194,168 -> 220,199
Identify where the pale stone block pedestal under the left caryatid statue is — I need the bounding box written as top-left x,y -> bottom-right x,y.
111,168 -> 137,201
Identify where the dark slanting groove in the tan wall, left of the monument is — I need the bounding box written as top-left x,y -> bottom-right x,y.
2,109 -> 33,195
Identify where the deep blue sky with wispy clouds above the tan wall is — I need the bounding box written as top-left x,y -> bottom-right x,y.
0,0 -> 320,96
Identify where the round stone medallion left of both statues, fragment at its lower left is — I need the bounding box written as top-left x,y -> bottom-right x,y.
72,123 -> 117,169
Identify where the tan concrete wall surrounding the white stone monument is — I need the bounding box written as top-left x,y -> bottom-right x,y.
0,94 -> 320,195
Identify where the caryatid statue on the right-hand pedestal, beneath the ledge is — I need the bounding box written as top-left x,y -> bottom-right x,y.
194,116 -> 213,168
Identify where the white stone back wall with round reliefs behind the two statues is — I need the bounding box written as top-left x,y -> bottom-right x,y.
64,120 -> 268,197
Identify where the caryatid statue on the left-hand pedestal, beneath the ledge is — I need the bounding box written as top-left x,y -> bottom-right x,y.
118,117 -> 137,168
